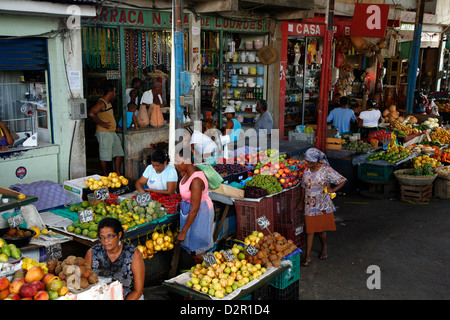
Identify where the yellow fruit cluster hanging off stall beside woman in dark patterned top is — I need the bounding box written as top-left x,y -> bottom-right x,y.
137,225 -> 178,259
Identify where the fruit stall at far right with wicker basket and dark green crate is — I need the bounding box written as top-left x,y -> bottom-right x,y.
353,109 -> 450,202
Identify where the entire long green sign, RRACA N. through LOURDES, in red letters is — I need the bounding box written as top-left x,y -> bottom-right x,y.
81,8 -> 270,32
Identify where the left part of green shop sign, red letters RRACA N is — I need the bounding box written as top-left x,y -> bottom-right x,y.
81,8 -> 189,28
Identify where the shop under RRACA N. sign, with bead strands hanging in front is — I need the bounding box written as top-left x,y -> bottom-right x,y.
82,7 -> 189,180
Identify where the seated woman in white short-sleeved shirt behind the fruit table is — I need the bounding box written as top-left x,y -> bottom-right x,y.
135,150 -> 178,196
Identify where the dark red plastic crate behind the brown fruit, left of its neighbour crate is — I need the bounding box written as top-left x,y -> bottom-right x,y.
234,197 -> 274,240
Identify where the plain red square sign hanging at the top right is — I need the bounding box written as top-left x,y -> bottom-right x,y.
350,3 -> 389,38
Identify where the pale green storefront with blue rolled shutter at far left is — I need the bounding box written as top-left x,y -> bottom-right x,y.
0,5 -> 87,187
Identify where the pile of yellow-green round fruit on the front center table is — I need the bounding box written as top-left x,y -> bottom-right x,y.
186,245 -> 266,299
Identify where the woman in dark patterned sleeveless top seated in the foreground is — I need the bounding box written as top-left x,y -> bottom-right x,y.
85,218 -> 145,300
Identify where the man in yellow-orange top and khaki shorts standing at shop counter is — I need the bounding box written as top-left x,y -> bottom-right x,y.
89,84 -> 124,176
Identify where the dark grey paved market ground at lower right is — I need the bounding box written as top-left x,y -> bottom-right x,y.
144,194 -> 450,300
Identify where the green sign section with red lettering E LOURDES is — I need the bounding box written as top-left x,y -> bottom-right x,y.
201,17 -> 270,32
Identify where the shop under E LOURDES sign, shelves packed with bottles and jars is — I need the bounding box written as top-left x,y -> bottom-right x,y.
197,16 -> 273,128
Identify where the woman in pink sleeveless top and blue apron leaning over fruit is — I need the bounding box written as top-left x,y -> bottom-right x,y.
175,150 -> 214,264
